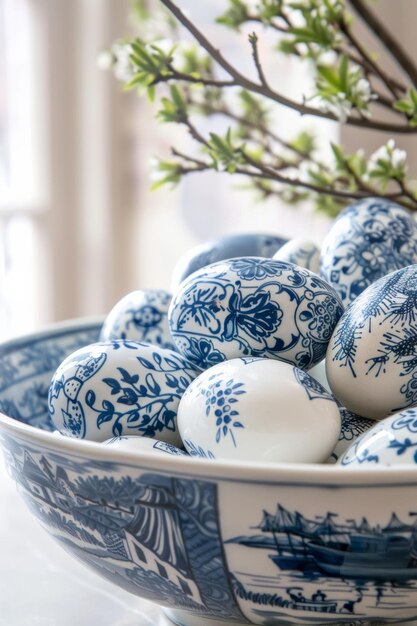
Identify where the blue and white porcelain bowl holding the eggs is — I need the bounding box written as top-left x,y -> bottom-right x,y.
0,321 -> 417,626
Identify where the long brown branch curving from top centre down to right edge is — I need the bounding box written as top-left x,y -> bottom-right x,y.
161,0 -> 417,134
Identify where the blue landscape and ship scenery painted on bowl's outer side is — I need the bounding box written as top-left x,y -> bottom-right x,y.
4,437 -> 417,626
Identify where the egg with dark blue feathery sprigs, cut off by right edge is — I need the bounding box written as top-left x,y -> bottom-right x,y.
326,265 -> 417,419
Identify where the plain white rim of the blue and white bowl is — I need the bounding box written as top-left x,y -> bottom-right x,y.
0,316 -> 417,488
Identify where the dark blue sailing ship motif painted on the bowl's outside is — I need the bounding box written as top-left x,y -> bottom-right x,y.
229,504 -> 417,581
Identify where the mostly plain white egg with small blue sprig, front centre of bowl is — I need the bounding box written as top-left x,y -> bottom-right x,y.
178,358 -> 340,463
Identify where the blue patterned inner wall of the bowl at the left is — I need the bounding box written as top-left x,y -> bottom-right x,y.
0,320 -> 101,431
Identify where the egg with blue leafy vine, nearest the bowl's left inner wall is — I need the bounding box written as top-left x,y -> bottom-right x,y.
48,341 -> 197,446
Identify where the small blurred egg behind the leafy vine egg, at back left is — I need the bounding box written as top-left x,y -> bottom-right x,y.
100,289 -> 176,350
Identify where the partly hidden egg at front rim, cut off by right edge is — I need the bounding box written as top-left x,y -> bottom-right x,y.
338,409 -> 417,468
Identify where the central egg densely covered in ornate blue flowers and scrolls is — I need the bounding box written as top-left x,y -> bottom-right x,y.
168,257 -> 343,369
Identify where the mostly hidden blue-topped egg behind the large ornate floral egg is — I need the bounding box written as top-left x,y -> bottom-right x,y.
171,233 -> 287,293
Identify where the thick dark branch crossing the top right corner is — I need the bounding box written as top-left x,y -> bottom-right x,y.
348,0 -> 417,88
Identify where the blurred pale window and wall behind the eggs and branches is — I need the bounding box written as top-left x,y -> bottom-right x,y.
0,0 -> 417,339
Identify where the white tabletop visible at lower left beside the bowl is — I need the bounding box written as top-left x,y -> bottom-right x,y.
0,464 -> 172,626
